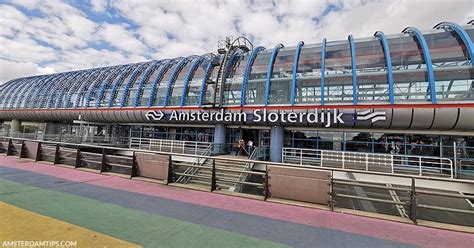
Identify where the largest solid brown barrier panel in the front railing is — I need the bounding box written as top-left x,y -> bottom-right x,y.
267,165 -> 332,205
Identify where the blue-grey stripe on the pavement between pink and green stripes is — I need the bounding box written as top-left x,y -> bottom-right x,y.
0,168 -> 412,247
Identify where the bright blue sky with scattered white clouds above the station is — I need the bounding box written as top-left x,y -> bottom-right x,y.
0,0 -> 474,83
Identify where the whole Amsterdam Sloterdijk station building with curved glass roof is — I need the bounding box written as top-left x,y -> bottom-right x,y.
0,22 -> 474,162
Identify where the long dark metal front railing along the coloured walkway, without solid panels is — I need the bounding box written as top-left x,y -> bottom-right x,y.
0,137 -> 474,228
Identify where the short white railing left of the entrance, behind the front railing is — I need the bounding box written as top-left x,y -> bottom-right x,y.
129,138 -> 212,155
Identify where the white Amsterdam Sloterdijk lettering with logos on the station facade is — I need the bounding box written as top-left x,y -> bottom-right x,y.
145,109 -> 386,127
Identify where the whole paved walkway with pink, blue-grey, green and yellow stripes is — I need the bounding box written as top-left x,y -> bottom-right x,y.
0,156 -> 474,247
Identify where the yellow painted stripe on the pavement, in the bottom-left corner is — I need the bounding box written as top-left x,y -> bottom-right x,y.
0,202 -> 139,248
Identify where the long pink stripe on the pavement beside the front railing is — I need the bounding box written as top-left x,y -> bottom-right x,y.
0,156 -> 474,247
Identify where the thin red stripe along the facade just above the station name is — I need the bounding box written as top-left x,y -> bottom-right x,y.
0,103 -> 474,112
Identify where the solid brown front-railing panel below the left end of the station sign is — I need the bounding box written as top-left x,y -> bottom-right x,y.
132,152 -> 171,183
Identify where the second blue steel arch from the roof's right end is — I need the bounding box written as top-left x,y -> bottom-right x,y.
402,27 -> 436,104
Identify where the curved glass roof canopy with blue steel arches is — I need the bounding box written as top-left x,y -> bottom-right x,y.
0,23 -> 474,109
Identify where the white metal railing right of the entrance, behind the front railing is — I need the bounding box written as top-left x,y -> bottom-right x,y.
282,148 -> 454,178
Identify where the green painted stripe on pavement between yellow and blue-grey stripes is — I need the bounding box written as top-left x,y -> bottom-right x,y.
0,179 -> 282,247
